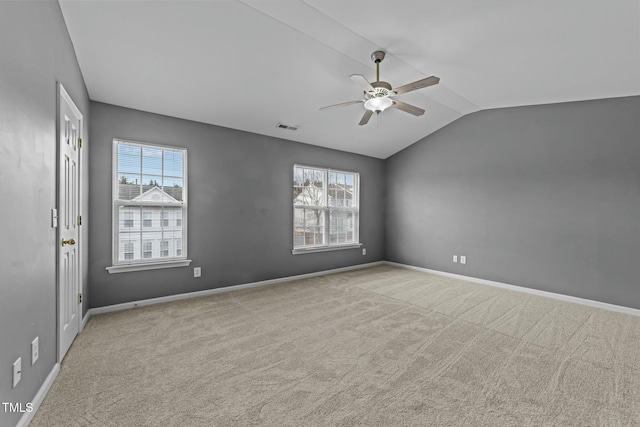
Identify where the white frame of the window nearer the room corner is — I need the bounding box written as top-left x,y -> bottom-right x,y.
290,163 -> 363,255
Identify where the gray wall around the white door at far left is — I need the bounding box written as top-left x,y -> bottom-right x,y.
0,1 -> 89,426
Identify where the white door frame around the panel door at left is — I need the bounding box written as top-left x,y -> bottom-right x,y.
55,82 -> 85,363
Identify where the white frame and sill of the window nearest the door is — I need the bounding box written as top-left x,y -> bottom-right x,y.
106,138 -> 191,273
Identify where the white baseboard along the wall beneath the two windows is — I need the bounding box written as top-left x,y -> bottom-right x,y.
87,261 -> 385,315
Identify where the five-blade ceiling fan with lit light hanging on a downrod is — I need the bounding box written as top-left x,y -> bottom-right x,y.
320,50 -> 440,126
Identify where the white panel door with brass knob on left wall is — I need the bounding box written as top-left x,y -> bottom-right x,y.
58,85 -> 82,361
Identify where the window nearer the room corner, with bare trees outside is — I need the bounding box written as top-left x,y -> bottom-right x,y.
292,165 -> 360,254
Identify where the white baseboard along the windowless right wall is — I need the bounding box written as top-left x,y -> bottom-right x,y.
383,261 -> 640,316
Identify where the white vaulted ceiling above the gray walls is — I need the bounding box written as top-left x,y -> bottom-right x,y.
60,0 -> 640,158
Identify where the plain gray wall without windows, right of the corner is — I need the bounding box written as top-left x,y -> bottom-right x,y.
386,97 -> 640,308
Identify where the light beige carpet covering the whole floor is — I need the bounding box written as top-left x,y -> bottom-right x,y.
31,266 -> 640,427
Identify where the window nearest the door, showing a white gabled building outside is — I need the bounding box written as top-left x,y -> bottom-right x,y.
107,139 -> 191,273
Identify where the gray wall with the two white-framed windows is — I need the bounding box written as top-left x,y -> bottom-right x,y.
89,102 -> 385,307
